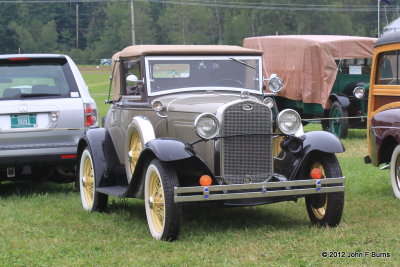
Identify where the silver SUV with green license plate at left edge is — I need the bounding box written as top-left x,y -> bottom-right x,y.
0,54 -> 98,182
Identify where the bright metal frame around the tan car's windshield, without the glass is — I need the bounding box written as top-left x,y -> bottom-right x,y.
145,55 -> 263,96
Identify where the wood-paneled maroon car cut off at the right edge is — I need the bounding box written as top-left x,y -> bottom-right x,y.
365,33 -> 400,198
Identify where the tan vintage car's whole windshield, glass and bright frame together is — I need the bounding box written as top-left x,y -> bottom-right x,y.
146,56 -> 262,95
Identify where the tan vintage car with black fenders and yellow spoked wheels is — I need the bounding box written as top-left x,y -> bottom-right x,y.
78,45 -> 345,240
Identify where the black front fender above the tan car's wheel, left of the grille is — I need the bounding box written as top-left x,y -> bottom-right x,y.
126,138 -> 211,198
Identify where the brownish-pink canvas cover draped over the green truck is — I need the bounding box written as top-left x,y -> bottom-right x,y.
243,35 -> 377,108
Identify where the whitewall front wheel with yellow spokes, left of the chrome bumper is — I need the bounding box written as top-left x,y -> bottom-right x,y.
144,160 -> 182,241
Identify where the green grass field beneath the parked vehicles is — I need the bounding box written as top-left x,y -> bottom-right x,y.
0,68 -> 400,266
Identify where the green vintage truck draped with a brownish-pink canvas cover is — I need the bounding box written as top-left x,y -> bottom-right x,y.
243,35 -> 376,138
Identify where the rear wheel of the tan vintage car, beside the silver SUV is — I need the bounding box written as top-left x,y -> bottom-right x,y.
79,147 -> 108,211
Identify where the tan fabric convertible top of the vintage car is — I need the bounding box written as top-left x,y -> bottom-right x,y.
112,45 -> 262,101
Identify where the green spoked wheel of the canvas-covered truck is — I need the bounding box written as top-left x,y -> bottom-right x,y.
329,101 -> 349,138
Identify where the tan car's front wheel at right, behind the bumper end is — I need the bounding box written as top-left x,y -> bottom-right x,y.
306,153 -> 344,227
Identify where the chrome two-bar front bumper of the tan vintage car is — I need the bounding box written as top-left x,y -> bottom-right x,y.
174,177 -> 346,203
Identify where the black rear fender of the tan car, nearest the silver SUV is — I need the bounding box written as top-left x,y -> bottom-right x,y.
77,128 -> 122,187
